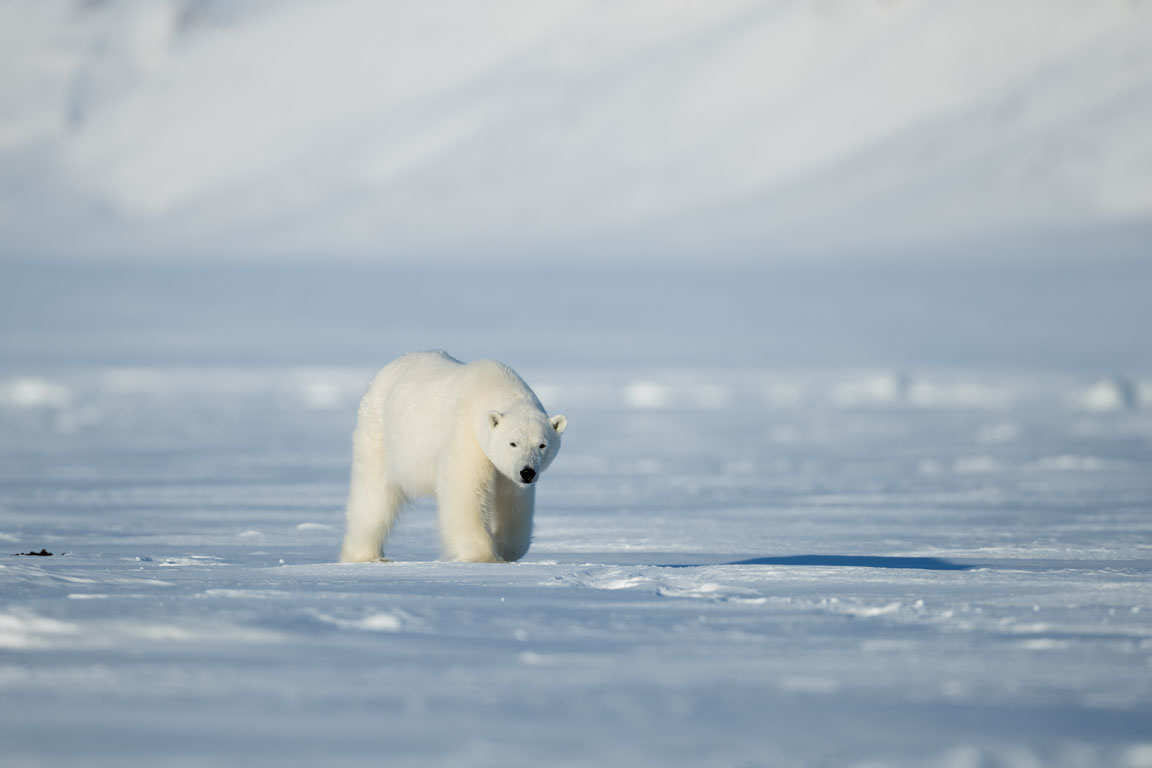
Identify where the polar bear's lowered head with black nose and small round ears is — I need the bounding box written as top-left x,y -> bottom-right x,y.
477,405 -> 568,487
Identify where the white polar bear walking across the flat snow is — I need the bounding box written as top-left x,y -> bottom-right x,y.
340,350 -> 568,563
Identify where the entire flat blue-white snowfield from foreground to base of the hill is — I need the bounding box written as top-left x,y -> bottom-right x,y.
0,254 -> 1152,768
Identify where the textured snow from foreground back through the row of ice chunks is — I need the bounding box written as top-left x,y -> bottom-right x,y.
0,356 -> 1152,767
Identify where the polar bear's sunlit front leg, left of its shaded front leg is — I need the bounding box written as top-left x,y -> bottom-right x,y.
437,462 -> 505,563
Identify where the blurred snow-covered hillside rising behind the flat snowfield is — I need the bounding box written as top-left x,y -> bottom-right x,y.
0,0 -> 1152,258
